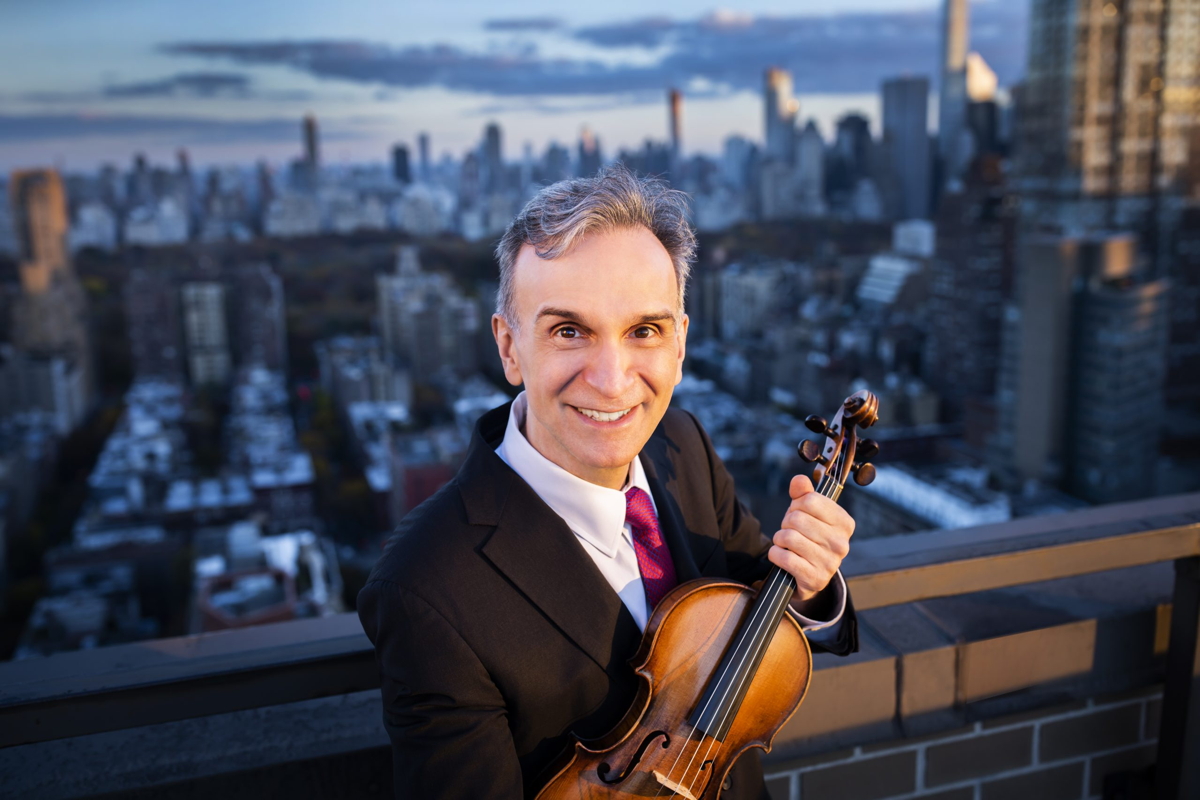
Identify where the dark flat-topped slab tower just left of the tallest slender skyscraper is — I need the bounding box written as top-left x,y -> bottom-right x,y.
883,78 -> 931,219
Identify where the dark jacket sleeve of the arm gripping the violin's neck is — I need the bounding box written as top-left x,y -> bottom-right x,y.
689,413 -> 858,656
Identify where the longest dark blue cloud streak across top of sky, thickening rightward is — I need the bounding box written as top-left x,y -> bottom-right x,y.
163,2 -> 1027,97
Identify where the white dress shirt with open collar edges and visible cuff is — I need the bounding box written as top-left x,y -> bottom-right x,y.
496,392 -> 846,638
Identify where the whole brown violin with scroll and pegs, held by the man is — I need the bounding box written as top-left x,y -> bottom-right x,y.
536,391 -> 880,800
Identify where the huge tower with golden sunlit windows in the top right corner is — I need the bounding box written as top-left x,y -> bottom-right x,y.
1018,0 -> 1200,217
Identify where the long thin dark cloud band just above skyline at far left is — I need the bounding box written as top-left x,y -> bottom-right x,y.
0,114 -> 358,144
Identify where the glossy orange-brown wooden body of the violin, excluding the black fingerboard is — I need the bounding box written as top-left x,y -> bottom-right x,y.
536,579 -> 812,800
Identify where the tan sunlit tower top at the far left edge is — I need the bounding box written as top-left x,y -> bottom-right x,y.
8,169 -> 70,294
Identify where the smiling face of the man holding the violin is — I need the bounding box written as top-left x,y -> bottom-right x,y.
492,227 -> 688,488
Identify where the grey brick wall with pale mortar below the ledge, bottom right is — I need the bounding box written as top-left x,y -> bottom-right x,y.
766,687 -> 1162,800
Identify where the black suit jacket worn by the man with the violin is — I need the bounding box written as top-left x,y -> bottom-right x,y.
358,405 -> 858,800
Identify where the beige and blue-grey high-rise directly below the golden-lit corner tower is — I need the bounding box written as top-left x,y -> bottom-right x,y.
992,234 -> 1166,503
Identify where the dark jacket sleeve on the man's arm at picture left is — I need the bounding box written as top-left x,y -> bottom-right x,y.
358,579 -> 522,800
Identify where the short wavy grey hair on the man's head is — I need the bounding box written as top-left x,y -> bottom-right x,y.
496,163 -> 696,330
